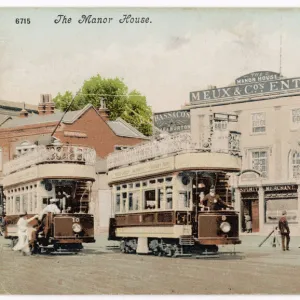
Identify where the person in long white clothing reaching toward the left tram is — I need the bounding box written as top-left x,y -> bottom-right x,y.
13,212 -> 38,254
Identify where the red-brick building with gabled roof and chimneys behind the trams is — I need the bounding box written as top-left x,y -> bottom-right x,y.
0,95 -> 147,229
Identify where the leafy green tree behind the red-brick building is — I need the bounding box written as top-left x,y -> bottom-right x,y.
53,74 -> 152,136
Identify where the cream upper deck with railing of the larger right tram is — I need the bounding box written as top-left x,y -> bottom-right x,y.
107,131 -> 241,184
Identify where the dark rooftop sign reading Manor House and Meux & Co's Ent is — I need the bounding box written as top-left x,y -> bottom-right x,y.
190,71 -> 300,104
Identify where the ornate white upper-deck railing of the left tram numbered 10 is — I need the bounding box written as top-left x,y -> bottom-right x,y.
3,146 -> 96,175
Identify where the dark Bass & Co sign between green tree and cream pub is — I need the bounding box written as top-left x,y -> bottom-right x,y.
153,110 -> 191,133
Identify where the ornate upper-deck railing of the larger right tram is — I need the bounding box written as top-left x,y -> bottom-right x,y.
107,131 -> 240,169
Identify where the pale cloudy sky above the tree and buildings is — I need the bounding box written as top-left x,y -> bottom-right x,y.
0,8 -> 300,112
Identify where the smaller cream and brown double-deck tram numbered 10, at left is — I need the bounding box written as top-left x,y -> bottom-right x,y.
3,144 -> 96,253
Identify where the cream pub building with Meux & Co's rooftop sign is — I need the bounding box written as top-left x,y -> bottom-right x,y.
184,71 -> 300,235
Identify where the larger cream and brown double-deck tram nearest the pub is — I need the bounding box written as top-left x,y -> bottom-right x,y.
108,127 -> 241,256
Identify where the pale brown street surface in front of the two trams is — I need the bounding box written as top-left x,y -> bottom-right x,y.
0,237 -> 300,295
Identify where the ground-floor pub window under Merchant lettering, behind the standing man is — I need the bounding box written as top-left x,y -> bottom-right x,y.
266,199 -> 298,224
